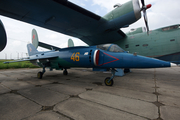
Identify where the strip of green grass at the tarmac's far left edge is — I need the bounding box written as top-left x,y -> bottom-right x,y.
0,60 -> 39,69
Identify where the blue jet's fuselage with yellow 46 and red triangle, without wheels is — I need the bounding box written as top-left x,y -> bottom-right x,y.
30,44 -> 171,70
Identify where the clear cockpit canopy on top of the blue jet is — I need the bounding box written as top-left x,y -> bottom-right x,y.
97,44 -> 125,52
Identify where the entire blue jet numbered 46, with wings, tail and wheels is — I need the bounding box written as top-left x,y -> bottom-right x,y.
5,29 -> 177,86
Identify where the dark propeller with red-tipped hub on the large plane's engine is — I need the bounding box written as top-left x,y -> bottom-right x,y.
141,0 -> 152,35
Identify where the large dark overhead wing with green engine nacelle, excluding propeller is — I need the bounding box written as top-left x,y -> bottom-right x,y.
0,0 -> 141,45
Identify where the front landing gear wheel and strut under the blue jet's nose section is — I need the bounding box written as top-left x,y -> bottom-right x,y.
104,68 -> 117,86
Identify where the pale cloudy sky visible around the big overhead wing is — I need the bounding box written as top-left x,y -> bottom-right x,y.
0,0 -> 180,59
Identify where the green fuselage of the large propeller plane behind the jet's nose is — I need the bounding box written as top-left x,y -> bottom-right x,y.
115,25 -> 180,64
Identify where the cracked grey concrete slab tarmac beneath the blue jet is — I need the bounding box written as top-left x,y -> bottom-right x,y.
0,67 -> 180,120
